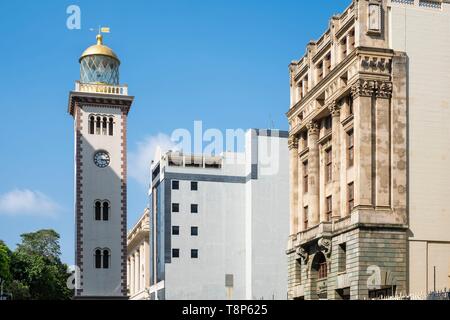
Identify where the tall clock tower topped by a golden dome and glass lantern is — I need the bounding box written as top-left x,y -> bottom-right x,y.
68,34 -> 134,299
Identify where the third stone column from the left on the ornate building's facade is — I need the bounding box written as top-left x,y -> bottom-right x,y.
328,101 -> 345,220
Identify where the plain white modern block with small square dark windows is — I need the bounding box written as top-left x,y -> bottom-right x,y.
150,130 -> 289,300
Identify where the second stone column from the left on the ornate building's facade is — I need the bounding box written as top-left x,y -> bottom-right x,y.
307,121 -> 320,226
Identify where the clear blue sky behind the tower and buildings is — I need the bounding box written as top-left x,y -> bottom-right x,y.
0,0 -> 350,264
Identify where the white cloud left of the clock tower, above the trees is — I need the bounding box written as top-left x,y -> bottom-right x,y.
0,189 -> 61,217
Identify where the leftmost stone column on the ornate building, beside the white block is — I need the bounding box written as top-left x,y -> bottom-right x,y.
288,136 -> 298,235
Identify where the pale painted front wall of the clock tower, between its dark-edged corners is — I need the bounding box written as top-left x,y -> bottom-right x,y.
81,106 -> 123,296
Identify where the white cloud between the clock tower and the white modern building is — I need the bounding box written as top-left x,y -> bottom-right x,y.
128,133 -> 175,186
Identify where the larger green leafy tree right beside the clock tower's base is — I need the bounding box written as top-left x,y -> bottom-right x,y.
10,230 -> 73,300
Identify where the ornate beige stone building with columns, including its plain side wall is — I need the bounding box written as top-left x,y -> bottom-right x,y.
287,0 -> 450,299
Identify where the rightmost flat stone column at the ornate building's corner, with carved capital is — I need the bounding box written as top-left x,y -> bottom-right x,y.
375,82 -> 392,207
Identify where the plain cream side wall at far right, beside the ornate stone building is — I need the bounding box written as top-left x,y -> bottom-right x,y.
389,1 -> 450,293
